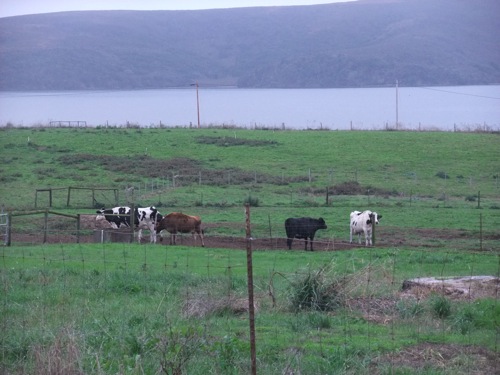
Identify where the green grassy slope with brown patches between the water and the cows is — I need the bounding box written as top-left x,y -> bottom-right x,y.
0,128 -> 500,210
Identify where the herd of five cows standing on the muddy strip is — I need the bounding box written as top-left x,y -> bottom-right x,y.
96,206 -> 382,251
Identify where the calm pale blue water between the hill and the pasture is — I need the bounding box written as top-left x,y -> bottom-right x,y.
0,85 -> 500,131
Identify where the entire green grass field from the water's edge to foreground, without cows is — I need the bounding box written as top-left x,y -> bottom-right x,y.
0,128 -> 500,375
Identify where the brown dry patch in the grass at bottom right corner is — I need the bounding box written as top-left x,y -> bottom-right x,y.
370,343 -> 500,375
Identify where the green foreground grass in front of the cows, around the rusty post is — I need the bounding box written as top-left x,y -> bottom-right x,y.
0,244 -> 500,374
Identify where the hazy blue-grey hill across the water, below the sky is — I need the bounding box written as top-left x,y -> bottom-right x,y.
0,0 -> 500,90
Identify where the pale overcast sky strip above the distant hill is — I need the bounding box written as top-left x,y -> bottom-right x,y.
0,0 -> 354,17
